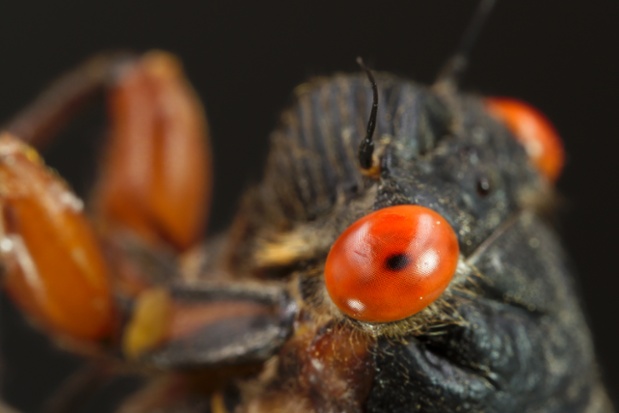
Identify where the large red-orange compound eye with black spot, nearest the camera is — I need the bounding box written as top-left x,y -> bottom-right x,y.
325,205 -> 459,322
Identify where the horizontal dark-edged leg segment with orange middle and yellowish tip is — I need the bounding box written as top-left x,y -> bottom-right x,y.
123,282 -> 297,369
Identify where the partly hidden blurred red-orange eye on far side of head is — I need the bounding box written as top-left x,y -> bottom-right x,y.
486,98 -> 565,181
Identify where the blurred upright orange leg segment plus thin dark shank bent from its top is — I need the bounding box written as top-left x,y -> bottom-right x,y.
4,51 -> 212,251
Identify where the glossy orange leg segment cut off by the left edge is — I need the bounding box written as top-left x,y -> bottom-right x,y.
0,134 -> 115,341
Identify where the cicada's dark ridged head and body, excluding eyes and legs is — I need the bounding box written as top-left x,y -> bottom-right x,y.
185,75 -> 611,412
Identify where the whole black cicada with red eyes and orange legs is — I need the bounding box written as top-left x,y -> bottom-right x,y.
0,1 -> 612,413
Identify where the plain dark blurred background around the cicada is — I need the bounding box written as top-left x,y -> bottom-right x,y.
0,0 -> 619,412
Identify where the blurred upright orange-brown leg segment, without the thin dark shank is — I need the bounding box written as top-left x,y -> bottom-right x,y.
95,51 -> 211,251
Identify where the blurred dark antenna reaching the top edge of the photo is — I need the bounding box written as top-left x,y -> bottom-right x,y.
436,0 -> 496,86
